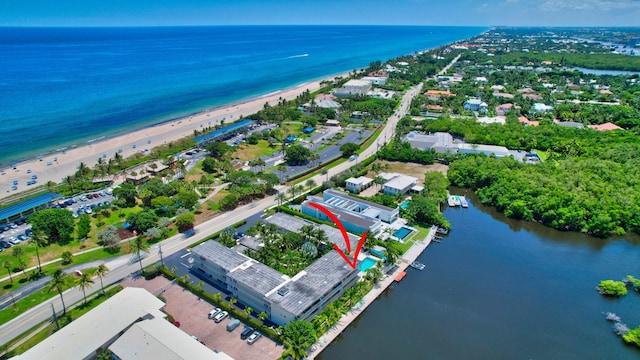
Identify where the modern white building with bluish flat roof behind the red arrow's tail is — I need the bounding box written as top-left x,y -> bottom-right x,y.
301,189 -> 400,235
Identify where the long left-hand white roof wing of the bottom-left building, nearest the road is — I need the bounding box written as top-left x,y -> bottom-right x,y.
14,288 -> 166,360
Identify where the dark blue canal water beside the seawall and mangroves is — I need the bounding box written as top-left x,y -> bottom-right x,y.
320,190 -> 640,360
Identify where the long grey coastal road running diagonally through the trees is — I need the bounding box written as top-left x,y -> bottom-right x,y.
0,58 -> 436,344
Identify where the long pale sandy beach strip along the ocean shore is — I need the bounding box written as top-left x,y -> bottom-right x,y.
0,74 -> 347,199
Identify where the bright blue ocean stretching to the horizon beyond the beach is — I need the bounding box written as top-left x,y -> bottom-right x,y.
0,26 -> 486,165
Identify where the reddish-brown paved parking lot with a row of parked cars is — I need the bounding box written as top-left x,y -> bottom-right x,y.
122,277 -> 284,360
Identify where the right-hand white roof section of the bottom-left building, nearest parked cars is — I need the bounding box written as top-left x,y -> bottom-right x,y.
109,318 -> 233,360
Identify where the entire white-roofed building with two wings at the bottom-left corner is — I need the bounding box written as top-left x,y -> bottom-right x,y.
13,287 -> 233,360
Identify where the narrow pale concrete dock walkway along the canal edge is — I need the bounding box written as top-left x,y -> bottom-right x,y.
306,226 -> 436,359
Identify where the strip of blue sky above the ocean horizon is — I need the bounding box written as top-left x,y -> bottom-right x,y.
0,0 -> 640,26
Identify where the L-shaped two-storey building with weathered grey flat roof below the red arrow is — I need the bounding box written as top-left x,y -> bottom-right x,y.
192,240 -> 358,326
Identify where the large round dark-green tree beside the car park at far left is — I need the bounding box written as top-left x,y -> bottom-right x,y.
28,209 -> 75,243
